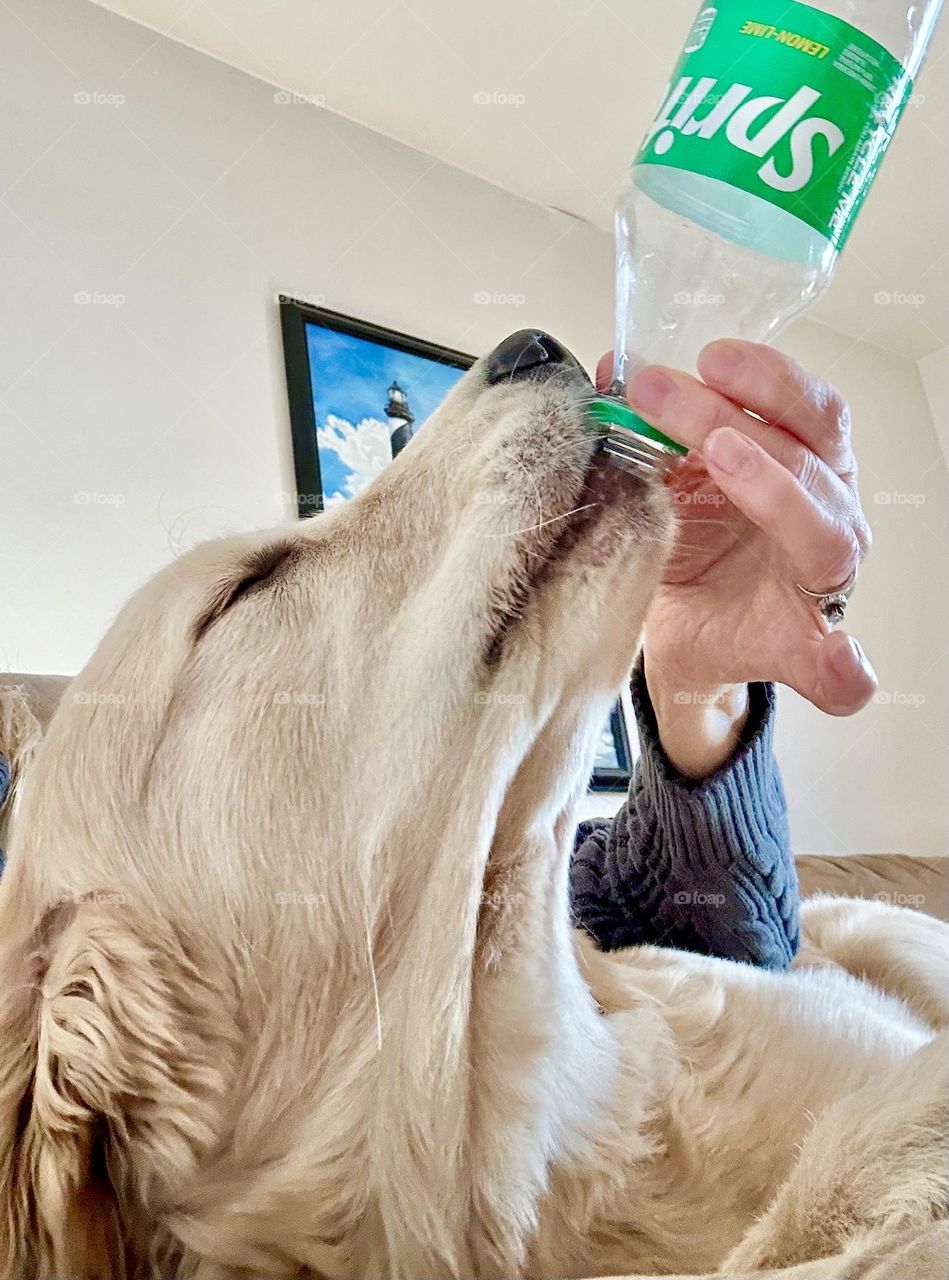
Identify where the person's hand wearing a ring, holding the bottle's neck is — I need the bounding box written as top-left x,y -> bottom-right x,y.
601,339 -> 876,768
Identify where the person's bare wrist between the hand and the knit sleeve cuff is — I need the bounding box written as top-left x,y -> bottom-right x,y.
643,650 -> 749,778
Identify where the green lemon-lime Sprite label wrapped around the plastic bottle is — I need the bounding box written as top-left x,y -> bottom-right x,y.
634,0 -> 912,248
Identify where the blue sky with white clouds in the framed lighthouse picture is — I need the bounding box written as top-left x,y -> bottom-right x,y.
306,321 -> 464,507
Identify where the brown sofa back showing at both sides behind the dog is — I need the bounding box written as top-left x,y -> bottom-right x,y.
0,672 -> 949,920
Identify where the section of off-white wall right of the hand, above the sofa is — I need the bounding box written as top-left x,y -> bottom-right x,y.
779,325 -> 949,854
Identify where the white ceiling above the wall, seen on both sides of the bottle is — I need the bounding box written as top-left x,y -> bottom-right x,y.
92,0 -> 949,358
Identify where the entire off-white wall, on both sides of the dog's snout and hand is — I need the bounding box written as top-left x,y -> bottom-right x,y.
0,0 -> 949,852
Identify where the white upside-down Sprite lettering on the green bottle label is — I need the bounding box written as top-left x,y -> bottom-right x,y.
647,76 -> 844,191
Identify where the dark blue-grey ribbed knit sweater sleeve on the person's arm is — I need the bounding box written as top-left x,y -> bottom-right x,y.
571,659 -> 798,969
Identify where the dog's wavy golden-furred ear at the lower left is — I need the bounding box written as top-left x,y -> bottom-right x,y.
0,893 -> 234,1280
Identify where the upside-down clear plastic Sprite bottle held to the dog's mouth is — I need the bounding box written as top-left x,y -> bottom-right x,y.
594,0 -> 941,456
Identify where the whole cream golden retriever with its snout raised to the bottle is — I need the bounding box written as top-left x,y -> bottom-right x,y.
0,335 -> 949,1280
